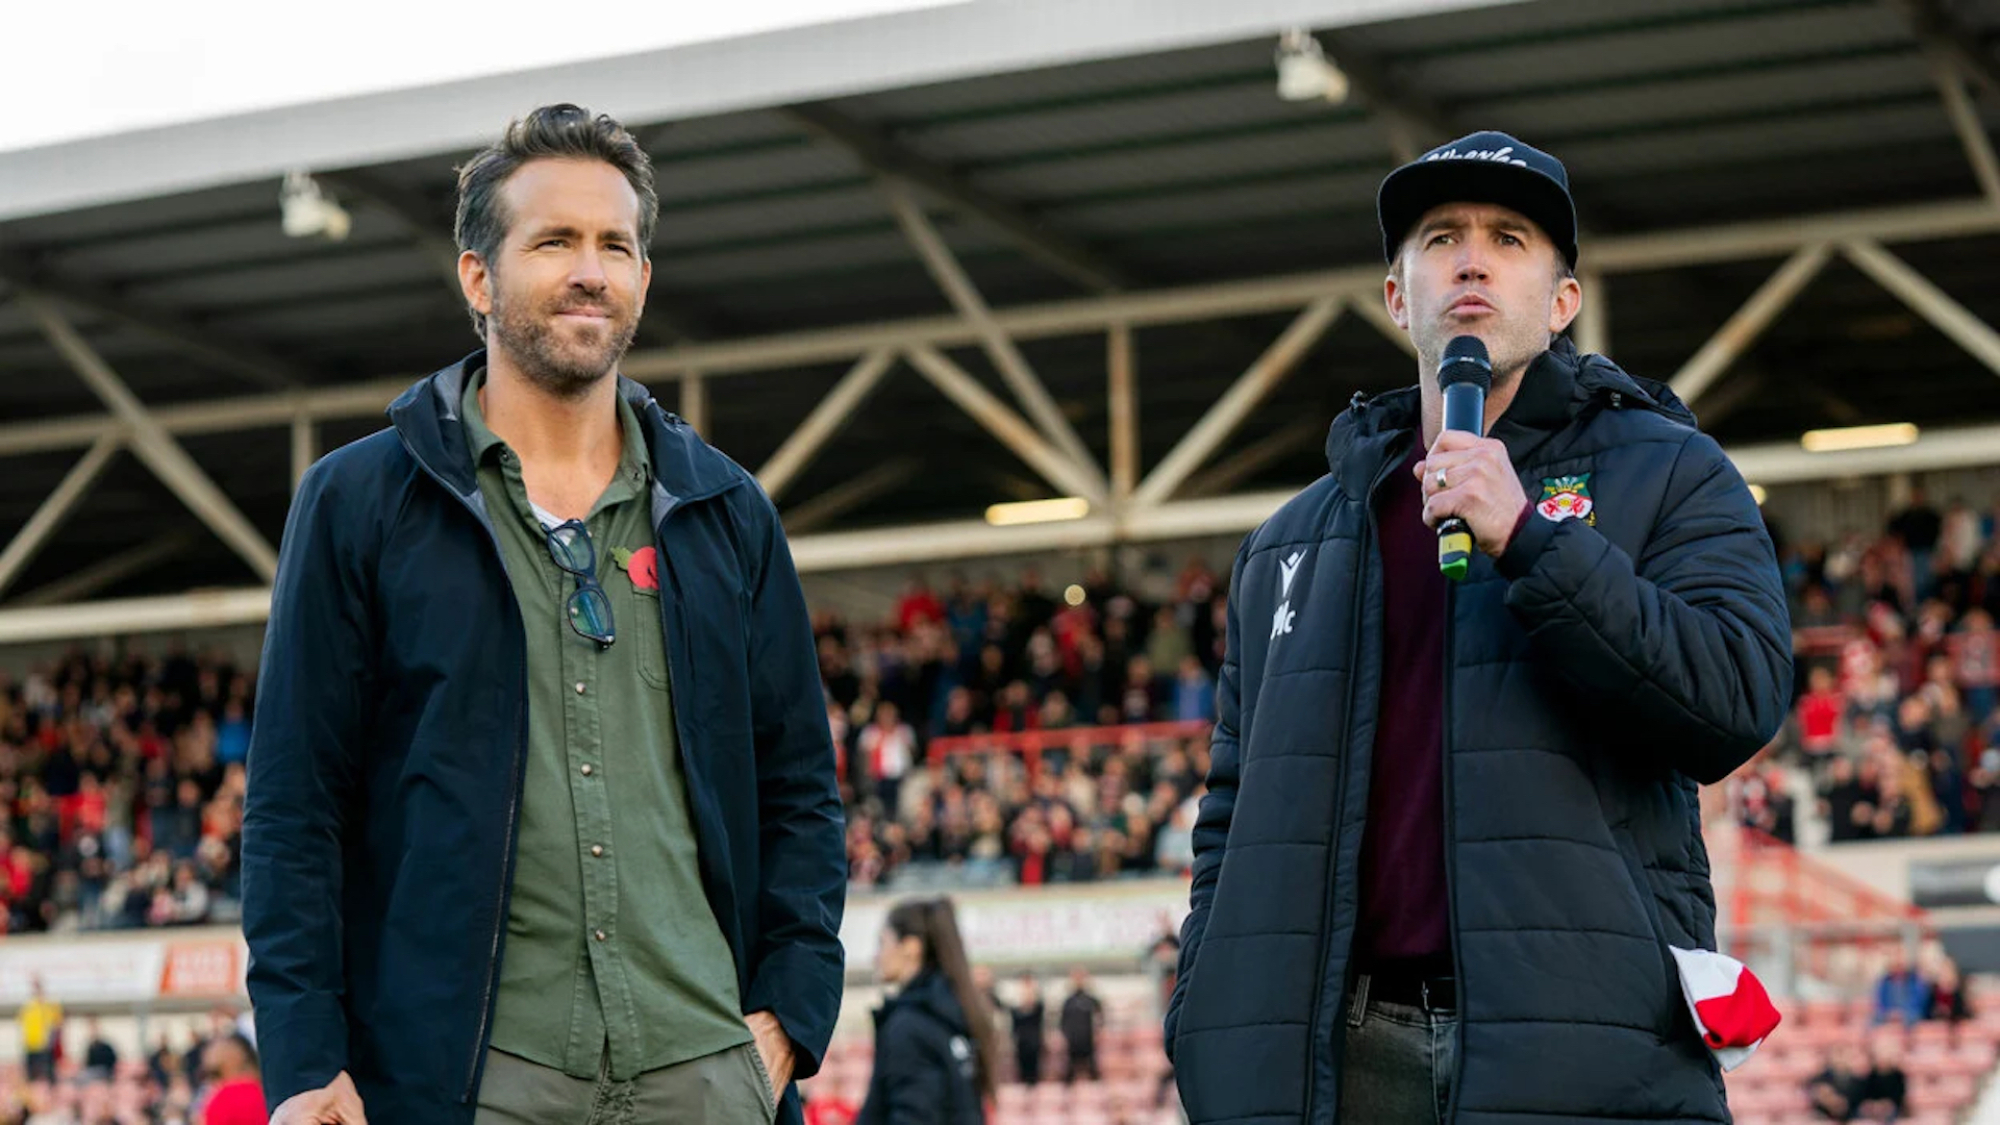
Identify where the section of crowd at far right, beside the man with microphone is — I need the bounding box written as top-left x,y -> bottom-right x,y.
1730,488 -> 2000,843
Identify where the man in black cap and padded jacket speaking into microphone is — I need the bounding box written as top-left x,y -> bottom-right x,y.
1166,132 -> 1792,1125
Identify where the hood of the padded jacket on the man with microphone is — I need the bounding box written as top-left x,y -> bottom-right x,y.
1326,336 -> 1694,496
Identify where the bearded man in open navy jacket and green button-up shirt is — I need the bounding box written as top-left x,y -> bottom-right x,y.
242,104 -> 846,1125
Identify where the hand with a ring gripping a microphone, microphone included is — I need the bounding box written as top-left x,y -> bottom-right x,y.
1416,336 -> 1528,581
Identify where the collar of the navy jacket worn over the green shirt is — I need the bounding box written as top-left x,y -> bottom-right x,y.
388,350 -> 744,522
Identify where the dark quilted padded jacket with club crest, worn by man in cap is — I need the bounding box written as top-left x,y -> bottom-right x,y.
1166,340 -> 1792,1125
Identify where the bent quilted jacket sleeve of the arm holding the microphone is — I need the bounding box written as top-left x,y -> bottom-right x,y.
1498,432 -> 1792,785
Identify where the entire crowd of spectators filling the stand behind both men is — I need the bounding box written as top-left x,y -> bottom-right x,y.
0,482 -> 2000,933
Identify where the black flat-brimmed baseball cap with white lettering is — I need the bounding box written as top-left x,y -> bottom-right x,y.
1376,132 -> 1576,268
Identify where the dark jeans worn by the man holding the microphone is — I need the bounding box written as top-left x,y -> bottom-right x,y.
1338,977 -> 1458,1125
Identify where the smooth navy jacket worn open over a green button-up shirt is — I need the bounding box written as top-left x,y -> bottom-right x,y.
242,352 -> 846,1125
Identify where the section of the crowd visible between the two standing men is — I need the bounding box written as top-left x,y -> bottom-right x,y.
816,560 -> 1224,887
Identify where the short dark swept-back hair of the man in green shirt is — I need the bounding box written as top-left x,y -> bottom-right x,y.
452,102 -> 660,340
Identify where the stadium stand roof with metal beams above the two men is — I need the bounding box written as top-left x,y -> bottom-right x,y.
0,0 -> 2000,620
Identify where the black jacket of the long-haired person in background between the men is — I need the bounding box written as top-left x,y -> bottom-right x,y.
854,973 -> 986,1125
